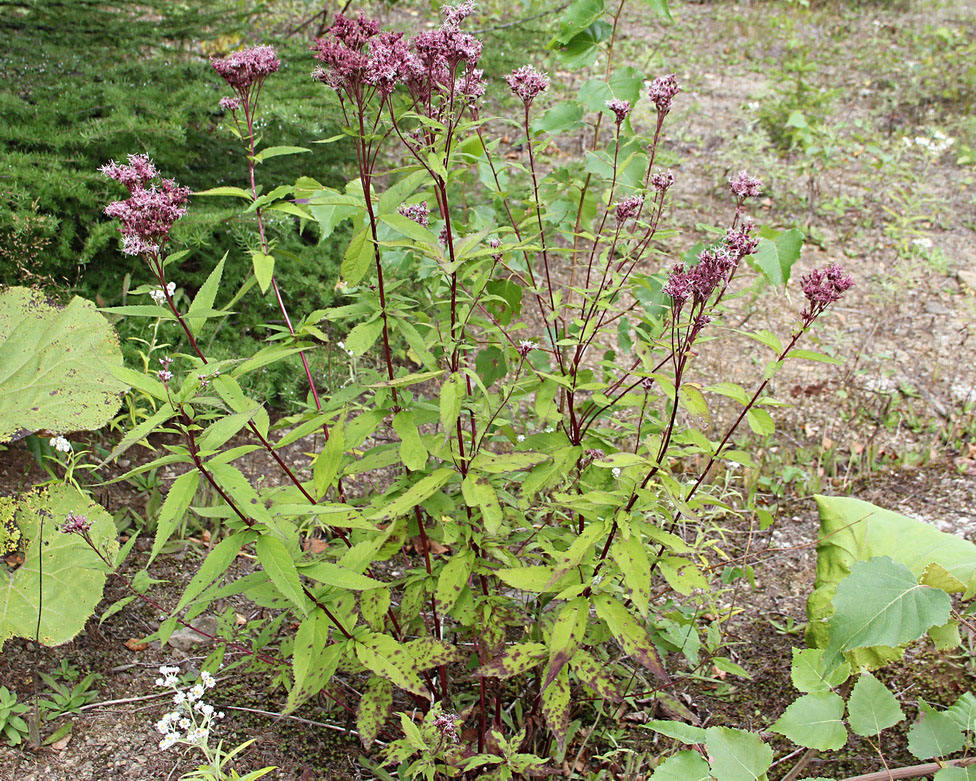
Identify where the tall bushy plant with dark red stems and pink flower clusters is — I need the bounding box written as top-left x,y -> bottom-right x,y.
95,3 -> 851,777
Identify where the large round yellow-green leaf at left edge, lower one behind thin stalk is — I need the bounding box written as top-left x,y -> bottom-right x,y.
0,485 -> 119,648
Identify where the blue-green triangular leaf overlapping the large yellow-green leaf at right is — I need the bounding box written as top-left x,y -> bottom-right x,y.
824,556 -> 952,666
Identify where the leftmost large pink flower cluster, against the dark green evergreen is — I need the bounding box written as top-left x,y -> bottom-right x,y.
99,155 -> 190,255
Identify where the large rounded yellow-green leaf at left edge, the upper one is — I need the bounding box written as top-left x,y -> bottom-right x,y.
0,287 -> 125,442
